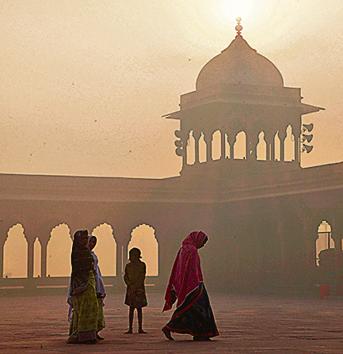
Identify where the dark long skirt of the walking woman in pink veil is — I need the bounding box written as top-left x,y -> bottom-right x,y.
165,283 -> 219,338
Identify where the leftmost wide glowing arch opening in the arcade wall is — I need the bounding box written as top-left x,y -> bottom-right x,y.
3,224 -> 28,278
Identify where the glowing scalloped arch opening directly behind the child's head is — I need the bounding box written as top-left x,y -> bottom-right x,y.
128,224 -> 159,276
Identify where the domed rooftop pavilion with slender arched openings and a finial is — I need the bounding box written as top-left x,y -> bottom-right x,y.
166,19 -> 322,173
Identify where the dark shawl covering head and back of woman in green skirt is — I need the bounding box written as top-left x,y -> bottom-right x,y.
70,230 -> 93,295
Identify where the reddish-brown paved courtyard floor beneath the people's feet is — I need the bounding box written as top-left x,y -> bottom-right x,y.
0,293 -> 343,354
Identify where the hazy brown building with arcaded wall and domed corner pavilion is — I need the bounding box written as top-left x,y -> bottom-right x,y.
0,24 -> 343,291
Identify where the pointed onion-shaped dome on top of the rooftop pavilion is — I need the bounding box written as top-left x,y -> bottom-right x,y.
196,32 -> 283,90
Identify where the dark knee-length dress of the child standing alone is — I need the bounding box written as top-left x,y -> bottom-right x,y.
124,260 -> 148,308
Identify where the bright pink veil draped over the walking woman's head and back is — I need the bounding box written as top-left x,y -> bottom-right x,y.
163,231 -> 208,311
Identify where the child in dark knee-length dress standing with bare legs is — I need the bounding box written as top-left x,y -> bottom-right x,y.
124,248 -> 148,334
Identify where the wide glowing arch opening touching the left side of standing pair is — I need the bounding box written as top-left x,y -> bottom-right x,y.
46,223 -> 73,277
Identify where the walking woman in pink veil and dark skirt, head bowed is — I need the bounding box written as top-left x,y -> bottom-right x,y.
162,231 -> 219,340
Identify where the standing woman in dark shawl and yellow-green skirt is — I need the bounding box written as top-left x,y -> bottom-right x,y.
68,230 -> 100,344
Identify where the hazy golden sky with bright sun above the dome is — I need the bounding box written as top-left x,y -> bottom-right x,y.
0,0 -> 343,177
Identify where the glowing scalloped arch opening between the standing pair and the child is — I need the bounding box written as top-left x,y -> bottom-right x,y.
92,223 -> 117,276
